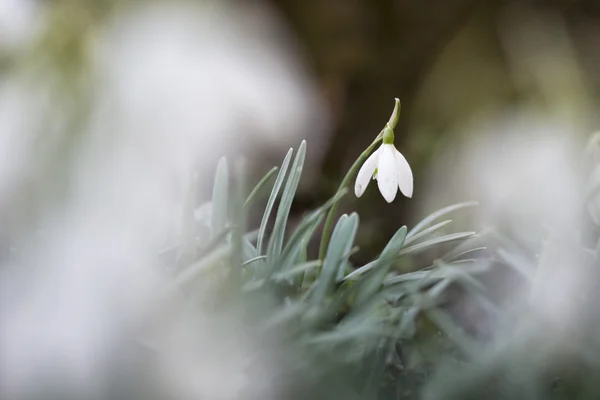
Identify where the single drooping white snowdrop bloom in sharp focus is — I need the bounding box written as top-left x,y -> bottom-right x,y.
354,124 -> 413,203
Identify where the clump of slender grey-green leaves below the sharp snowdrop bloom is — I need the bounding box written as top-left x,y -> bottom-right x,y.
162,142 -> 482,398
